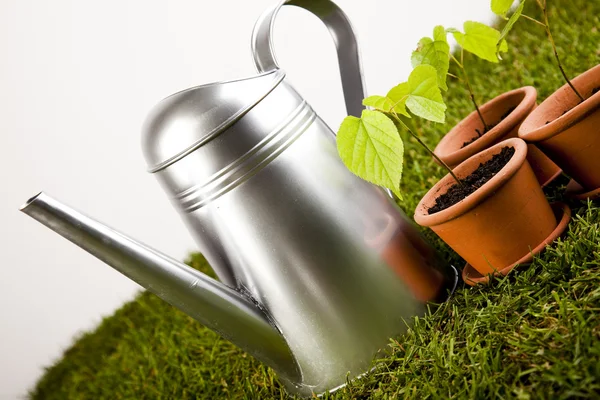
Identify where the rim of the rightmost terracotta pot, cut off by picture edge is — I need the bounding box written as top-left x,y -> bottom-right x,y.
519,64 -> 600,142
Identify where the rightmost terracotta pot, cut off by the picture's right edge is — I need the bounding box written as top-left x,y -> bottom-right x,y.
519,65 -> 600,190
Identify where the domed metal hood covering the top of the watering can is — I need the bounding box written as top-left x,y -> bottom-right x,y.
142,69 -> 285,172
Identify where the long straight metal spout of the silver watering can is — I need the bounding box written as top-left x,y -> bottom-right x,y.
20,192 -> 300,382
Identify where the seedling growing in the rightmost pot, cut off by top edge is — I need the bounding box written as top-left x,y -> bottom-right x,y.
491,0 -> 585,101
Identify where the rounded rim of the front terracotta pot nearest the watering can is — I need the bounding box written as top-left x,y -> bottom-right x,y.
414,138 -> 527,226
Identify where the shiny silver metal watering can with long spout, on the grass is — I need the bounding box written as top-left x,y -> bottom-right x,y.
21,0 -> 456,396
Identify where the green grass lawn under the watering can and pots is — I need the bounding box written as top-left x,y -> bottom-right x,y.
30,0 -> 600,399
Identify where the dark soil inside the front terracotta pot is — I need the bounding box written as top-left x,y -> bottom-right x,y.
428,146 -> 515,214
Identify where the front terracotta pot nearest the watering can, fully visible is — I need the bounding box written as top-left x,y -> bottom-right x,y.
415,138 -> 556,275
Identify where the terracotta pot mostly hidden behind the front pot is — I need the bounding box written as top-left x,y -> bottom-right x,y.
434,86 -> 561,186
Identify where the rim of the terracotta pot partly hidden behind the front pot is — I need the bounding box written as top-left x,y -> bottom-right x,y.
434,86 -> 537,165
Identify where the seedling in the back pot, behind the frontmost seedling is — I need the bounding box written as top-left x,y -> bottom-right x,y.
411,21 -> 508,137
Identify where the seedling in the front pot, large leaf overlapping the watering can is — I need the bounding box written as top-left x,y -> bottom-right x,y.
337,65 -> 461,198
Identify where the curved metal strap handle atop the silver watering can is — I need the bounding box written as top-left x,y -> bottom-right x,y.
252,0 -> 365,117
